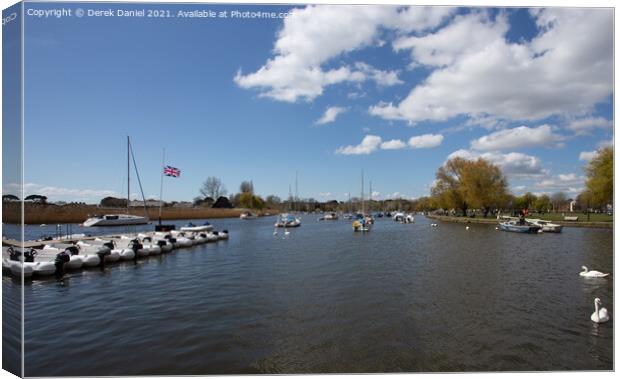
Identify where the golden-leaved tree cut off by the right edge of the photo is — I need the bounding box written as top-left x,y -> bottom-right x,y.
585,147 -> 614,206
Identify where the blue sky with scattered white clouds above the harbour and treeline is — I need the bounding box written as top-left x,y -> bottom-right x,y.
12,3 -> 613,202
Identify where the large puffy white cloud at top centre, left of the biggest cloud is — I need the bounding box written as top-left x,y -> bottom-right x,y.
234,5 -> 454,102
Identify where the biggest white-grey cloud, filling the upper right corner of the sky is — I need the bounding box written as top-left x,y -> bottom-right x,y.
369,8 -> 613,122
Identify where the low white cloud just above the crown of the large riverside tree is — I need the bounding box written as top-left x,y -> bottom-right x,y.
448,149 -> 547,177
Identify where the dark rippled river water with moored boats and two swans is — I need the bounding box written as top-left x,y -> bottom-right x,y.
2,215 -> 614,376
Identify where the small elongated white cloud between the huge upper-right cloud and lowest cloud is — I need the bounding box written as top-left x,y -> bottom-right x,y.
471,125 -> 563,151
